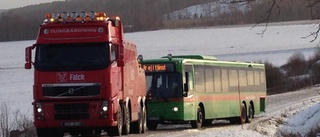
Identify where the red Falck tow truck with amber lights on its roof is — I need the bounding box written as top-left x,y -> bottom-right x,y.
25,11 -> 146,137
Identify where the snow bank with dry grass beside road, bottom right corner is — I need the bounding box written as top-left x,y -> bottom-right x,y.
248,89 -> 320,137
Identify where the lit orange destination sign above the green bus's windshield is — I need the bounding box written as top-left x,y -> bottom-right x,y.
142,63 -> 174,72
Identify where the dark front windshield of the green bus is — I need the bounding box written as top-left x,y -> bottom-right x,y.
146,73 -> 183,100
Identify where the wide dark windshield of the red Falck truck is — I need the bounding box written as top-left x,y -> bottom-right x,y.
34,42 -> 110,71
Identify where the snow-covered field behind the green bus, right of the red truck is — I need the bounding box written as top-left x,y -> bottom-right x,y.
125,23 -> 319,66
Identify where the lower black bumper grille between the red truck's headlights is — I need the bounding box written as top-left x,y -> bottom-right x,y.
54,104 -> 89,120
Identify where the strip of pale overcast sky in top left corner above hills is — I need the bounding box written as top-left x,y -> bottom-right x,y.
0,0 -> 61,9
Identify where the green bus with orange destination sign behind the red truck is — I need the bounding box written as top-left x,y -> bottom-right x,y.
140,54 -> 266,130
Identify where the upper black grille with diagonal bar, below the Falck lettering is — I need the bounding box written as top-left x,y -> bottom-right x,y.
42,83 -> 100,98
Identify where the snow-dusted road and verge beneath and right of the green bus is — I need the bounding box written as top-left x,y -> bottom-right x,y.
129,87 -> 320,137
